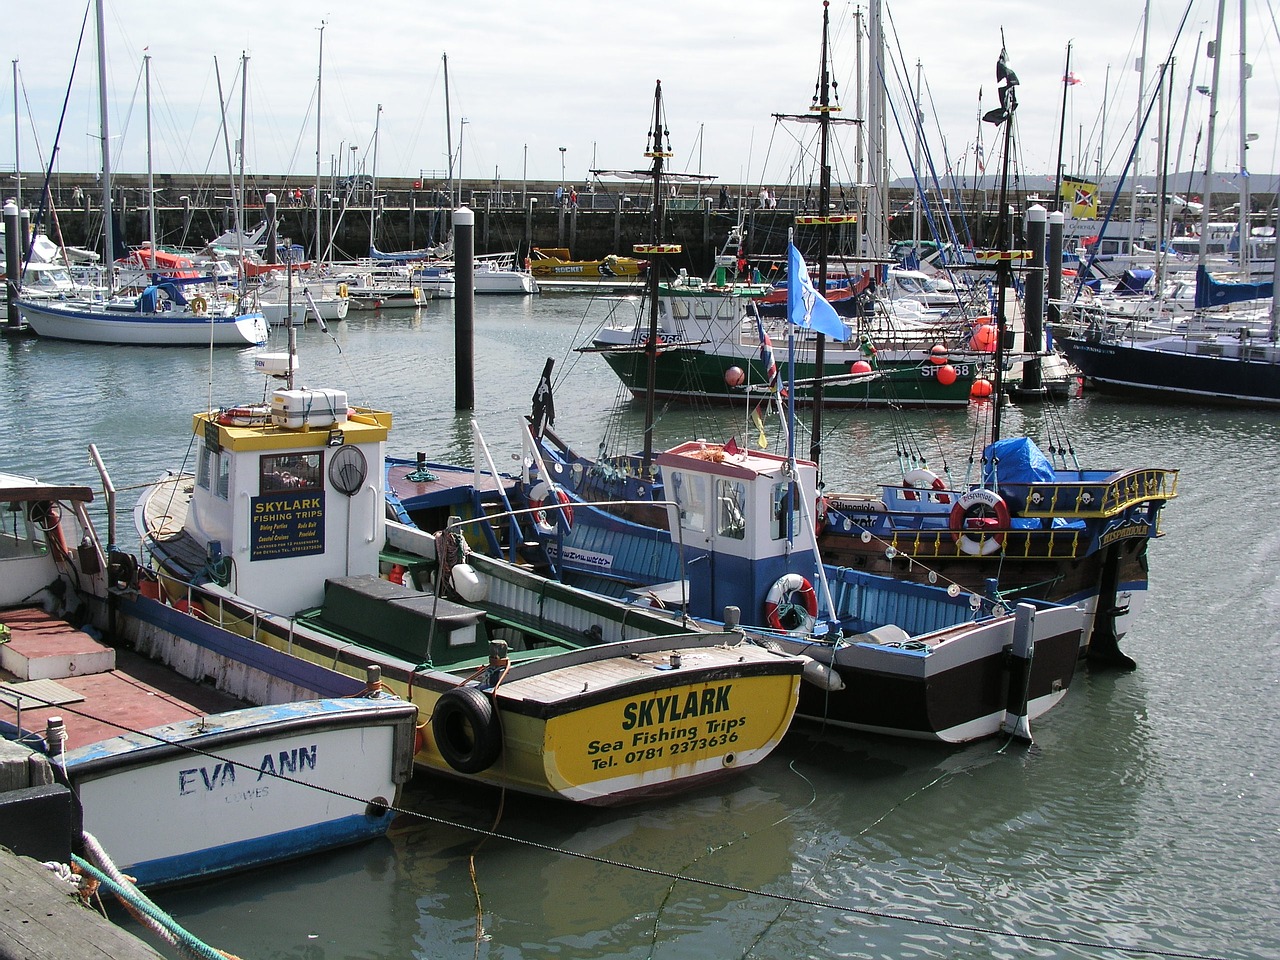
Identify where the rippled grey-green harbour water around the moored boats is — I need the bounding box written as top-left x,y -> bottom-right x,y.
0,294 -> 1280,960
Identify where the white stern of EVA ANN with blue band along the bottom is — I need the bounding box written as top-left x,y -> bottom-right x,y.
65,698 -> 416,887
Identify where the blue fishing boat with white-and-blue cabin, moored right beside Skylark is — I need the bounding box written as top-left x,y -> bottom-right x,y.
432,39 -> 1084,742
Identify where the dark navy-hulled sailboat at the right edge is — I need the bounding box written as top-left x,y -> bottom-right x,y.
1057,0 -> 1280,408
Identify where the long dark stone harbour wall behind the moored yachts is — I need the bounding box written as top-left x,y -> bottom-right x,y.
10,173 -> 1267,274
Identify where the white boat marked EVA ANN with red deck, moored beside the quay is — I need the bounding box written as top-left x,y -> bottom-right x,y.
0,474 -> 417,887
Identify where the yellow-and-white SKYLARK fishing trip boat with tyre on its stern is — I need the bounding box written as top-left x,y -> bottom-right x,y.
136,368 -> 804,804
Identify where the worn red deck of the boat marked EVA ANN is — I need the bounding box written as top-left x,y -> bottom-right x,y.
0,607 -> 247,750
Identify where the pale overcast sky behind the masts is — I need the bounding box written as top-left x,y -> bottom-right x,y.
0,0 -> 1280,196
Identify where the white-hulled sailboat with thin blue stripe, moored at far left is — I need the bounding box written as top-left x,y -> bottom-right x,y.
18,28 -> 268,347
